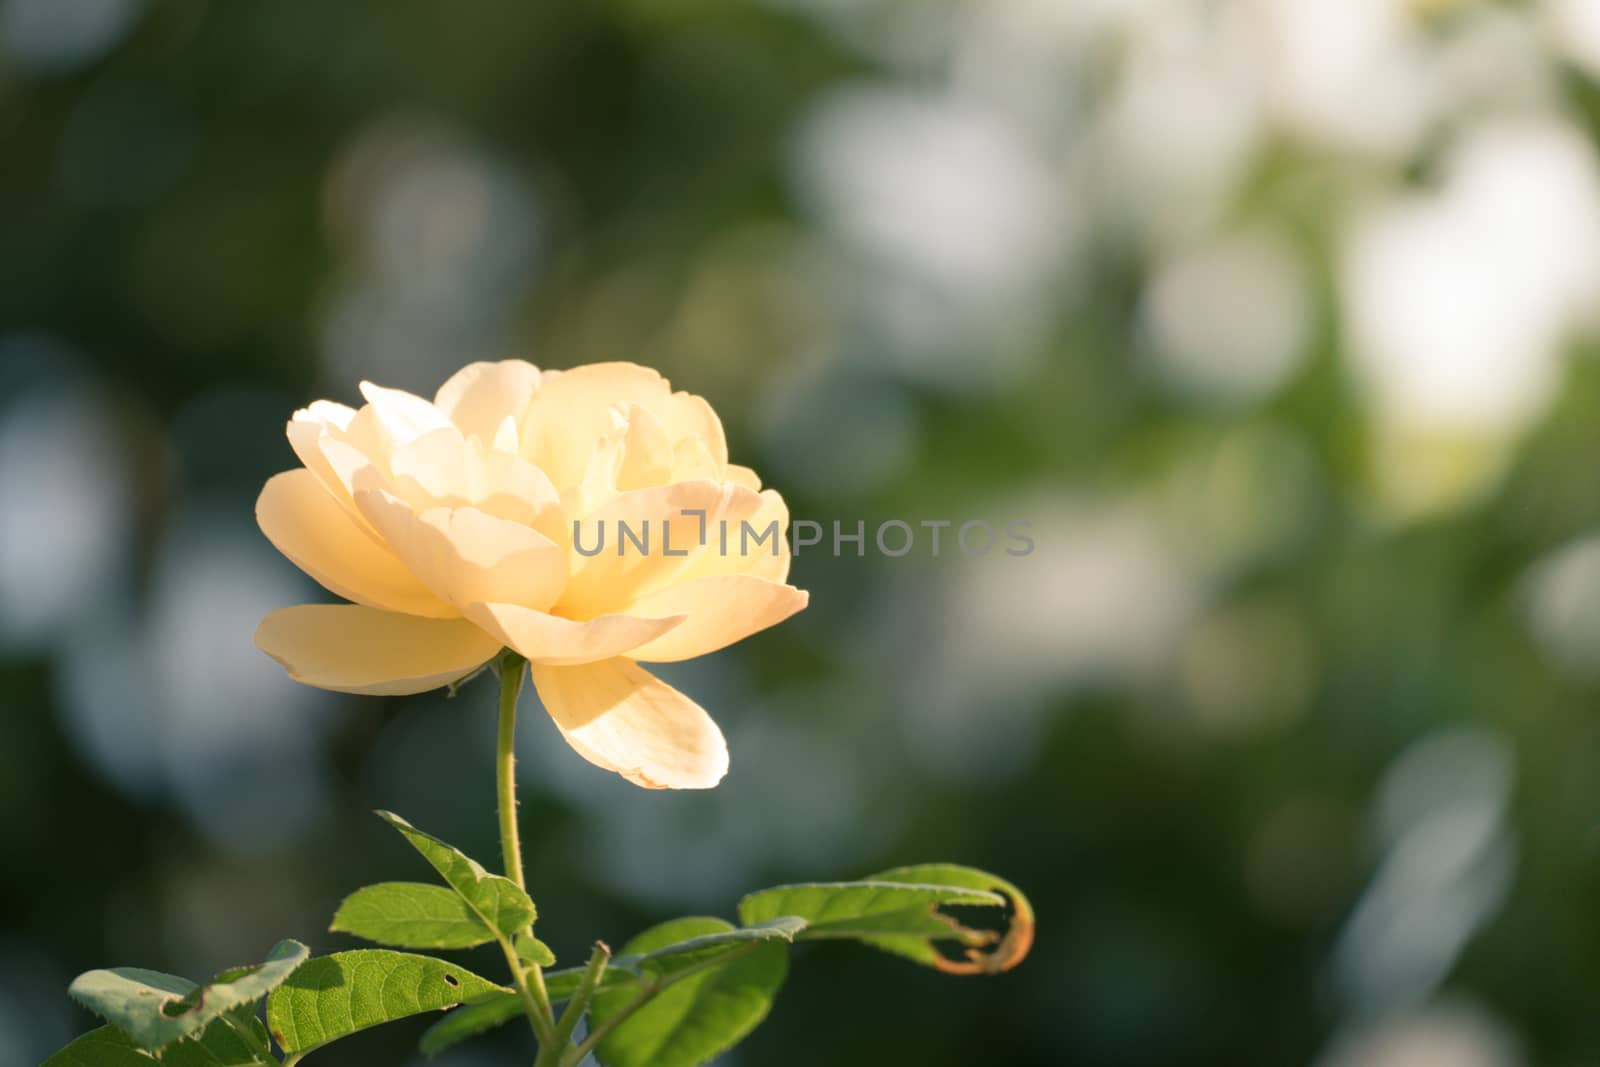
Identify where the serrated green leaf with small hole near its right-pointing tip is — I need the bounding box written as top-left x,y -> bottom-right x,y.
267,949 -> 504,1053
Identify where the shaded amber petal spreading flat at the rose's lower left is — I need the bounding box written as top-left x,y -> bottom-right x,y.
256,605 -> 499,696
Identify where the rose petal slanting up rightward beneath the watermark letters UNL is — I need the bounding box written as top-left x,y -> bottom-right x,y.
555,482 -> 762,619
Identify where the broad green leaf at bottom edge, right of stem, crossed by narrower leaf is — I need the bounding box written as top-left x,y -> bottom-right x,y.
589,918 -> 789,1067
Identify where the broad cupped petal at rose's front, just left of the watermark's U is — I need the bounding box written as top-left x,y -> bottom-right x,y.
355,488 -> 566,609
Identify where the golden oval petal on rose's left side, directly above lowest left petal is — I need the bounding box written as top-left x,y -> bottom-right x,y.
256,470 -> 461,619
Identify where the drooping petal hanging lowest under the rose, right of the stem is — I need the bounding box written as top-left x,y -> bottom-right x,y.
531,659 -> 728,789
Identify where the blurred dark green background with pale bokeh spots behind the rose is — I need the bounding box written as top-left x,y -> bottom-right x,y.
9,0 -> 1600,1067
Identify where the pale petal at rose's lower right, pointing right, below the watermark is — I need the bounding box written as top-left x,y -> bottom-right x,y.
629,574 -> 811,664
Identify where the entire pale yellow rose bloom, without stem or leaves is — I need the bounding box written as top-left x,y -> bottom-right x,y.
256,360 -> 808,789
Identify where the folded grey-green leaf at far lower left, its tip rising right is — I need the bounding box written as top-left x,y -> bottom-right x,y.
67,941 -> 310,1049
